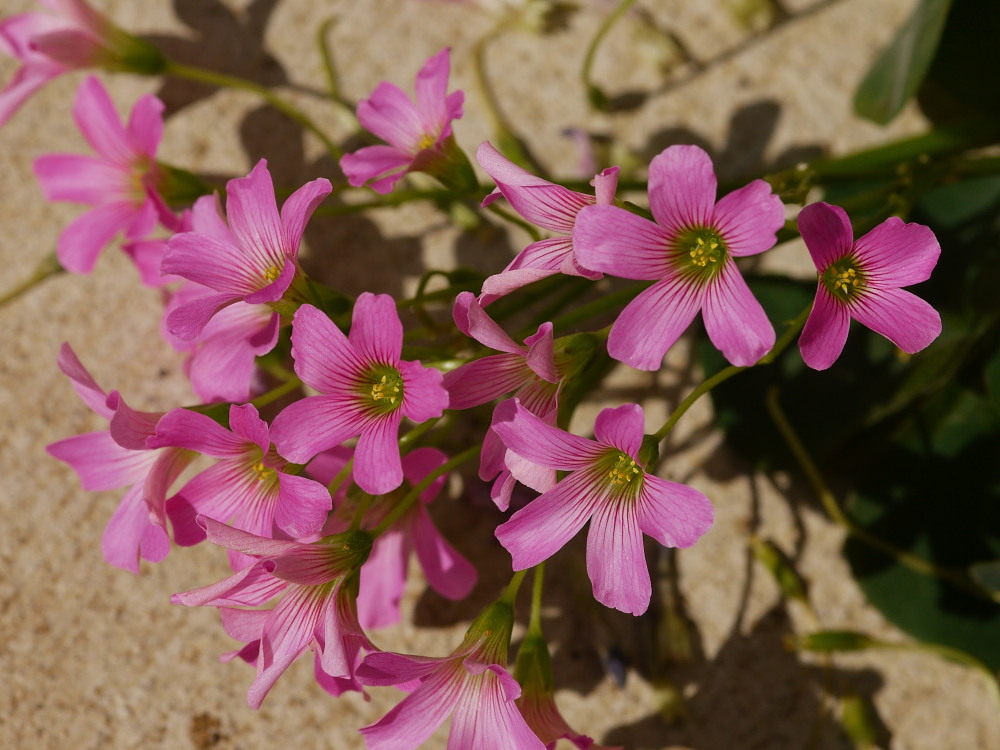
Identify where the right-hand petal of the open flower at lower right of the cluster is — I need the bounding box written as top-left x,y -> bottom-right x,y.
638,474 -> 715,547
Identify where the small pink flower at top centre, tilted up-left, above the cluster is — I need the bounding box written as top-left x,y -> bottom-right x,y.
340,47 -> 465,194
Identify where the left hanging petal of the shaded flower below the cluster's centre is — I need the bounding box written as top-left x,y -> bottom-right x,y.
358,527 -> 410,628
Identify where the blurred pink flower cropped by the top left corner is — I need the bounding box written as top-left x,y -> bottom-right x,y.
0,0 -> 164,126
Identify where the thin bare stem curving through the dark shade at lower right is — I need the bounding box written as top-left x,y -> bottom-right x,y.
767,387 -> 1000,602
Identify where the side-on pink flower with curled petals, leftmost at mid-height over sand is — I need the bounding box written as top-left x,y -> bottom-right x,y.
45,344 -> 195,573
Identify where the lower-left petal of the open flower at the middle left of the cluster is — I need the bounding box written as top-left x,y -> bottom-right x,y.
271,396 -> 367,464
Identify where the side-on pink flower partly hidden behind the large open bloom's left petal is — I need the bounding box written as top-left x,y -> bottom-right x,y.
476,141 -> 618,305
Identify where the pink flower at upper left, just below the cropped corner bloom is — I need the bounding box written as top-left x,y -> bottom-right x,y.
35,76 -> 176,273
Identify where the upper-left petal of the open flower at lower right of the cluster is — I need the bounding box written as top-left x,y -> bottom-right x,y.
492,400 -> 603,471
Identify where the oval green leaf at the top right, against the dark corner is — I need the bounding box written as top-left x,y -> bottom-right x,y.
854,0 -> 951,125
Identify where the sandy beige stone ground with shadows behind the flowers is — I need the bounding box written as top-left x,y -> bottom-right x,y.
0,0 -> 1000,750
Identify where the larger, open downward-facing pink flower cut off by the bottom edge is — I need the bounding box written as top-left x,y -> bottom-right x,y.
357,602 -> 544,750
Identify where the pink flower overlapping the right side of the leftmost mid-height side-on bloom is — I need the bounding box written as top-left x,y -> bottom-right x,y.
146,404 -> 333,564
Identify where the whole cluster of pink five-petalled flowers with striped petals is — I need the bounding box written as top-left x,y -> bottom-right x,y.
15,10 -> 941,749
